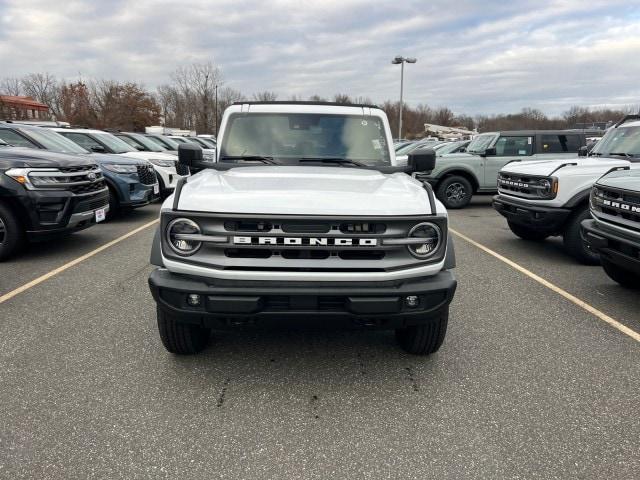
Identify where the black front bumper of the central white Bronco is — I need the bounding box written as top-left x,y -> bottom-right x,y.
149,268 -> 457,328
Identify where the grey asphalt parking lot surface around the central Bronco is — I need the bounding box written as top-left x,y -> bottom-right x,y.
0,197 -> 640,479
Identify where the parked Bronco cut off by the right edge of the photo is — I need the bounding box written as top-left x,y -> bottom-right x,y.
582,167 -> 640,289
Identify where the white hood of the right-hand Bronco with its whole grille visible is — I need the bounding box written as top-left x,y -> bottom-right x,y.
501,157 -> 629,176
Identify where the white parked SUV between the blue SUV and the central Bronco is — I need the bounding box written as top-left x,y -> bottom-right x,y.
54,128 -> 189,197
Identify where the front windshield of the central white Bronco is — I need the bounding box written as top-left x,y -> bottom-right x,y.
220,113 -> 391,165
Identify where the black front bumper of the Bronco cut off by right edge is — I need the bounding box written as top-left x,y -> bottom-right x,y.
581,219 -> 640,275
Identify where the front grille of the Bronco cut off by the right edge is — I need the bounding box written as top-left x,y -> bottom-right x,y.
591,185 -> 640,231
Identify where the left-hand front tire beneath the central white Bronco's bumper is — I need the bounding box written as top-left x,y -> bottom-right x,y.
157,307 -> 211,355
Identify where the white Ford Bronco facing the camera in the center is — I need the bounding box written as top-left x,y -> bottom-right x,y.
149,102 -> 456,355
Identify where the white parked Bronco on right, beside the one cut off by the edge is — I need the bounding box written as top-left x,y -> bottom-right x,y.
493,115 -> 640,264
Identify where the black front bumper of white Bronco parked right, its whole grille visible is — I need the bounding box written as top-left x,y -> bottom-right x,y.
493,195 -> 571,234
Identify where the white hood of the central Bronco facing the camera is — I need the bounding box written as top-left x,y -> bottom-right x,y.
172,166 -> 444,216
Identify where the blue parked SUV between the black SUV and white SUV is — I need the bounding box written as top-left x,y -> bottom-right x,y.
0,123 -> 159,216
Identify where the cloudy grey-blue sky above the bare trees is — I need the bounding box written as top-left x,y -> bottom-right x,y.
0,0 -> 640,114
